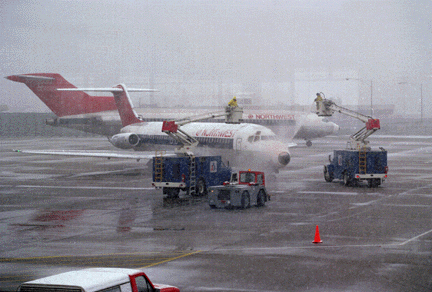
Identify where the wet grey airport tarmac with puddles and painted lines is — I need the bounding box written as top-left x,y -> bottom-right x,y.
0,136 -> 432,291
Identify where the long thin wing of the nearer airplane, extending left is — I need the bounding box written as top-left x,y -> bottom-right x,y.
13,149 -> 176,161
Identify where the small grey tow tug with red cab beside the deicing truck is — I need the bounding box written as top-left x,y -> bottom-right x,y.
208,170 -> 270,209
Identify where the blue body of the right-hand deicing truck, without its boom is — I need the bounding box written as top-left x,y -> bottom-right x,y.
324,149 -> 388,187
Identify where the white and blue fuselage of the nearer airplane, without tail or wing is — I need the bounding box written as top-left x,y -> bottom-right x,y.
111,122 -> 290,170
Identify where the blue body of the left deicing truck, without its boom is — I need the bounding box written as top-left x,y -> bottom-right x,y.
152,154 -> 231,198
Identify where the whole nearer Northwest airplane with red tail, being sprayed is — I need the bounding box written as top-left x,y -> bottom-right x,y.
16,84 -> 293,172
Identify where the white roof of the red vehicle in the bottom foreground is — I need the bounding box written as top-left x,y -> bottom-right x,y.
23,268 -> 141,292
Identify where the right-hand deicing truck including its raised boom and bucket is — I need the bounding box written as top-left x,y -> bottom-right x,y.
315,93 -> 388,187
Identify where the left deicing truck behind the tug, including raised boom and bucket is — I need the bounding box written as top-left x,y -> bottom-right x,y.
153,106 -> 243,198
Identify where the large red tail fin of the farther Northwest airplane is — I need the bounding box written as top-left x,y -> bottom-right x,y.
6,73 -> 117,117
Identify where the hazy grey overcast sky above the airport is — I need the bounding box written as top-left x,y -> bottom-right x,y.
0,0 -> 432,115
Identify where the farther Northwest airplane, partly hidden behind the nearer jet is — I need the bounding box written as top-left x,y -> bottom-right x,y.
6,73 -> 339,147
